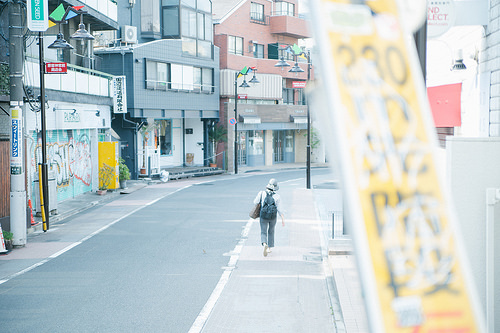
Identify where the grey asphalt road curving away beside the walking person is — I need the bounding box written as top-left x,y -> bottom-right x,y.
0,169 -> 336,332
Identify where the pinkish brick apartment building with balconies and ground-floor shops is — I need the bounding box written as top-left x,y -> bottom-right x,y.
213,0 -> 314,170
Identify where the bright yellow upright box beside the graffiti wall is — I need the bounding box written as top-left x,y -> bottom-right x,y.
99,142 -> 120,190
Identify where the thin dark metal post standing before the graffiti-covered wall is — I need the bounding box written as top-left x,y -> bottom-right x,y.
38,32 -> 50,232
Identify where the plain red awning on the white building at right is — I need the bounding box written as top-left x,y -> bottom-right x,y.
427,83 -> 462,127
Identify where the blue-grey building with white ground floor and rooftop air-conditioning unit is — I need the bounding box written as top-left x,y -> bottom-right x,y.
95,0 -> 219,177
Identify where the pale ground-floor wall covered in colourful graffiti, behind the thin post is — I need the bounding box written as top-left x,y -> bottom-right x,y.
30,129 -> 92,202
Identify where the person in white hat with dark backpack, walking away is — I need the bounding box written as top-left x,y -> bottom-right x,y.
253,178 -> 285,257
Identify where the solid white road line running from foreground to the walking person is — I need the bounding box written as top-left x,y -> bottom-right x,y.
188,219 -> 254,333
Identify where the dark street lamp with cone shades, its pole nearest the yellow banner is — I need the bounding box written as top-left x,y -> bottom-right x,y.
274,45 -> 311,189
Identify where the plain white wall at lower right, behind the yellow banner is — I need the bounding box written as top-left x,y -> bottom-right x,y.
446,137 -> 500,331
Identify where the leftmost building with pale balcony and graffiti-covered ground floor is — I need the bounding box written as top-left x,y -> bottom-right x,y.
0,0 -> 118,220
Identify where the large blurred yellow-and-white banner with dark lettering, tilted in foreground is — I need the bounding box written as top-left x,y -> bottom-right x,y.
310,0 -> 484,333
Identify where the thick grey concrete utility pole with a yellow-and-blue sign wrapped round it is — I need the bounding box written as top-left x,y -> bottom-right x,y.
9,1 -> 27,246
